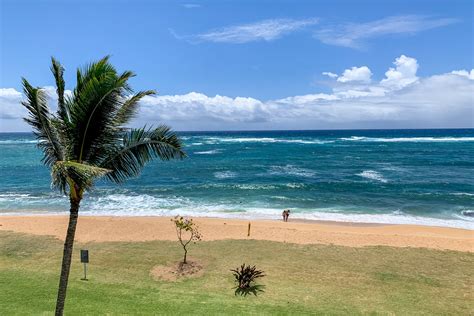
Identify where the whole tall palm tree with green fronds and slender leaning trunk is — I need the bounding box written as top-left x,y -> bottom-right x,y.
22,56 -> 186,315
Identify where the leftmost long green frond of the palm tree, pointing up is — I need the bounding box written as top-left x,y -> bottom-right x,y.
22,78 -> 64,166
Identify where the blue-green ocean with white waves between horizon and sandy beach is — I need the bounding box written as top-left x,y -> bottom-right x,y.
0,129 -> 474,229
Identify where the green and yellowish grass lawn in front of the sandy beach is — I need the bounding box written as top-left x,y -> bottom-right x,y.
0,232 -> 474,315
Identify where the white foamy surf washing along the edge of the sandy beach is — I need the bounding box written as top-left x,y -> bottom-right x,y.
0,193 -> 474,230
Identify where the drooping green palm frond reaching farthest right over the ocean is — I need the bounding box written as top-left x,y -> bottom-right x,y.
100,125 -> 186,182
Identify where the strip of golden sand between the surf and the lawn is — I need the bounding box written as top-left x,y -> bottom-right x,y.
0,216 -> 474,252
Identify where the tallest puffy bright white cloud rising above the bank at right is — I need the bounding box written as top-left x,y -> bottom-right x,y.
380,55 -> 418,89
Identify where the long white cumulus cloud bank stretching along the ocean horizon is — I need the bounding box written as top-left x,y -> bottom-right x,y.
0,55 -> 474,131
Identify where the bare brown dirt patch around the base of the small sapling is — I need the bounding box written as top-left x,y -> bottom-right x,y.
150,260 -> 204,282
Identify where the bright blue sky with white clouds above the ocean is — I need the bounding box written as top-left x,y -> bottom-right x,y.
0,0 -> 474,131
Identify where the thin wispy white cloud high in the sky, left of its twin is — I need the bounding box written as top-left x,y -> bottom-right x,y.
192,18 -> 318,44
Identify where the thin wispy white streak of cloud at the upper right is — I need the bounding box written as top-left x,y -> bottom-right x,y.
314,15 -> 458,48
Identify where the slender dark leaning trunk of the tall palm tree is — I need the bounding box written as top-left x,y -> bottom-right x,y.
55,198 -> 81,316
